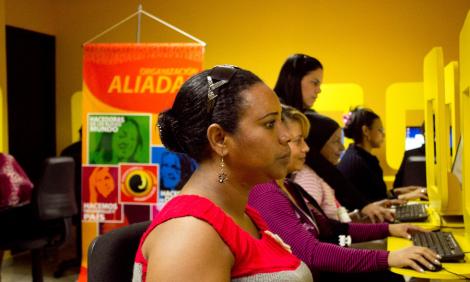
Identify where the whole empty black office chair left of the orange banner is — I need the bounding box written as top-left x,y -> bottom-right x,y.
0,157 -> 77,282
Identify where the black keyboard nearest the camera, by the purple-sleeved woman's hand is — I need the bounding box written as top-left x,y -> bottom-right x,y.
411,231 -> 465,262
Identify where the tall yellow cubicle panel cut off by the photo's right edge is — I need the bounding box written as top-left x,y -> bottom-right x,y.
459,8 -> 470,238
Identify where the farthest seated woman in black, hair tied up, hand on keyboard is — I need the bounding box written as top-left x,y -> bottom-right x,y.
338,107 -> 427,201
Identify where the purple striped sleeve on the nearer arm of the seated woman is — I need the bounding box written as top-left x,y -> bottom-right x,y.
248,182 -> 388,272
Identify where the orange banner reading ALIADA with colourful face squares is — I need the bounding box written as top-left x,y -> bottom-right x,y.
79,43 -> 204,281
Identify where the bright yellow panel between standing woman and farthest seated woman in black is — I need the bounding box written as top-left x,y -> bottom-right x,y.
314,83 -> 364,148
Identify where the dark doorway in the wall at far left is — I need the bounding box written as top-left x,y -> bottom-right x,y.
6,26 -> 56,183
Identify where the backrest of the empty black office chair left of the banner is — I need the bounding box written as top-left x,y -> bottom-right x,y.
35,157 -> 77,220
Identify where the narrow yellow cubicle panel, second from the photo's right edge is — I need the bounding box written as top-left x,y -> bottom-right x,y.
444,61 -> 460,165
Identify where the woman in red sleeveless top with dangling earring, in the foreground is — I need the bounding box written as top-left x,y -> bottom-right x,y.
134,66 -> 312,281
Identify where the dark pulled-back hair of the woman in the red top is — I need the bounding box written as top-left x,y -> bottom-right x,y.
158,66 -> 262,162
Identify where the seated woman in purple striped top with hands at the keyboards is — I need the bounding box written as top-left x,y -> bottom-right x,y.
248,108 -> 439,282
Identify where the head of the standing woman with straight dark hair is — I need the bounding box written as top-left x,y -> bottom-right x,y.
274,54 -> 323,112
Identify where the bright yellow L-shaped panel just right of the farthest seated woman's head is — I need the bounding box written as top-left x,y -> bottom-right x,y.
385,82 -> 424,169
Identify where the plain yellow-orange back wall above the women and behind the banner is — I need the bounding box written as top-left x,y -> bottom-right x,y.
4,0 -> 470,174
